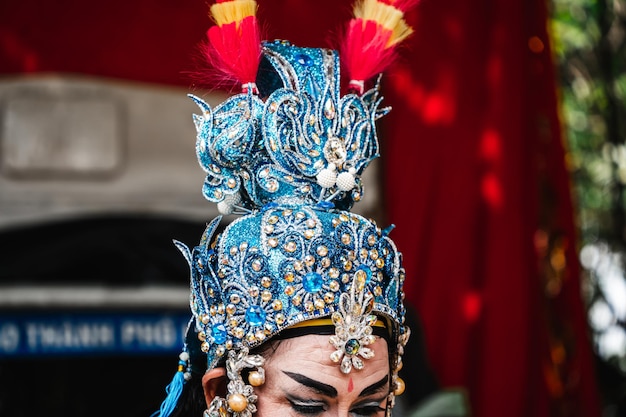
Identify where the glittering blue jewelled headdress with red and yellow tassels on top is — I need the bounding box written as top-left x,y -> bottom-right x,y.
152,0 -> 415,417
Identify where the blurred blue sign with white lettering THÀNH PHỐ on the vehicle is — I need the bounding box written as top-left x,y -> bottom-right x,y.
0,311 -> 191,358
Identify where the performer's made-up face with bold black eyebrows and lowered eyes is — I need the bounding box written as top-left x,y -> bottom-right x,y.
255,335 -> 390,417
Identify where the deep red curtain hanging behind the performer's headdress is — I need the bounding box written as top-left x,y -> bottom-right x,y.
0,0 -> 600,417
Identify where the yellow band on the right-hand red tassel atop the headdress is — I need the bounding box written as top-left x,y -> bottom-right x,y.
354,0 -> 413,47
